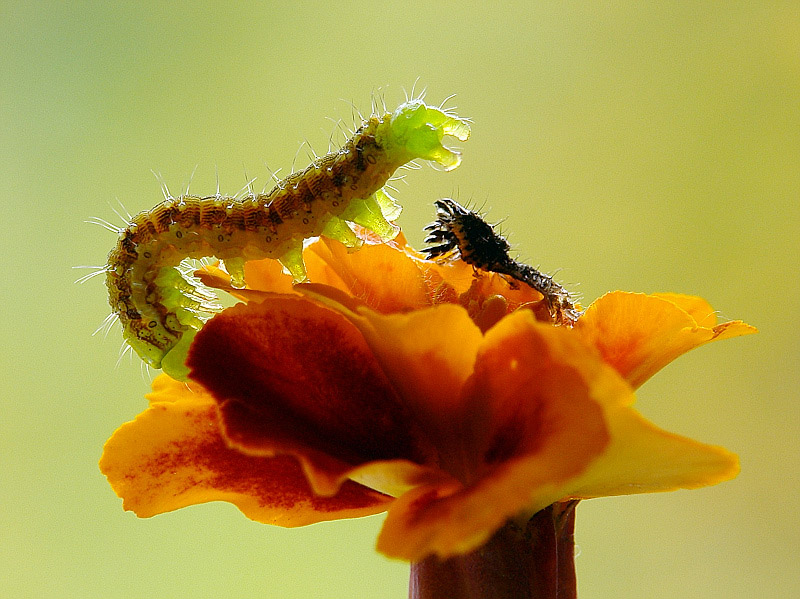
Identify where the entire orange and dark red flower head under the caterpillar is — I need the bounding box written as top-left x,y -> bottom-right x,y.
100,239 -> 755,561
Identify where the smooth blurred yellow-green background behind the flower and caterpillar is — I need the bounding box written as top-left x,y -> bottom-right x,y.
0,0 -> 800,599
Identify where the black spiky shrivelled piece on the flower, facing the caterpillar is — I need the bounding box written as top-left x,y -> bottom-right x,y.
422,198 -> 581,326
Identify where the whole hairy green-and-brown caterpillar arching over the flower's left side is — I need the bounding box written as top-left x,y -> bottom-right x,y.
105,100 -> 470,378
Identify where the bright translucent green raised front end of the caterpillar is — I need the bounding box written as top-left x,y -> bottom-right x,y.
378,100 -> 470,171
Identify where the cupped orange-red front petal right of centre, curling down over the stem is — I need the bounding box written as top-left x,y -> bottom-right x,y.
378,311 -> 632,561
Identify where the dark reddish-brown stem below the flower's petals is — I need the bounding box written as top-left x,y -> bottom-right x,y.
408,501 -> 578,599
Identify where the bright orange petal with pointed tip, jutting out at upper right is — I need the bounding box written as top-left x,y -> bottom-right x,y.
575,291 -> 756,388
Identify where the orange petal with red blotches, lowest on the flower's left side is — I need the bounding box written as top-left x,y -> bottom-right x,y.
100,375 -> 391,526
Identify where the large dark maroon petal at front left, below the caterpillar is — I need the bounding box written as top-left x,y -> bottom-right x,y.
187,296 -> 430,495
